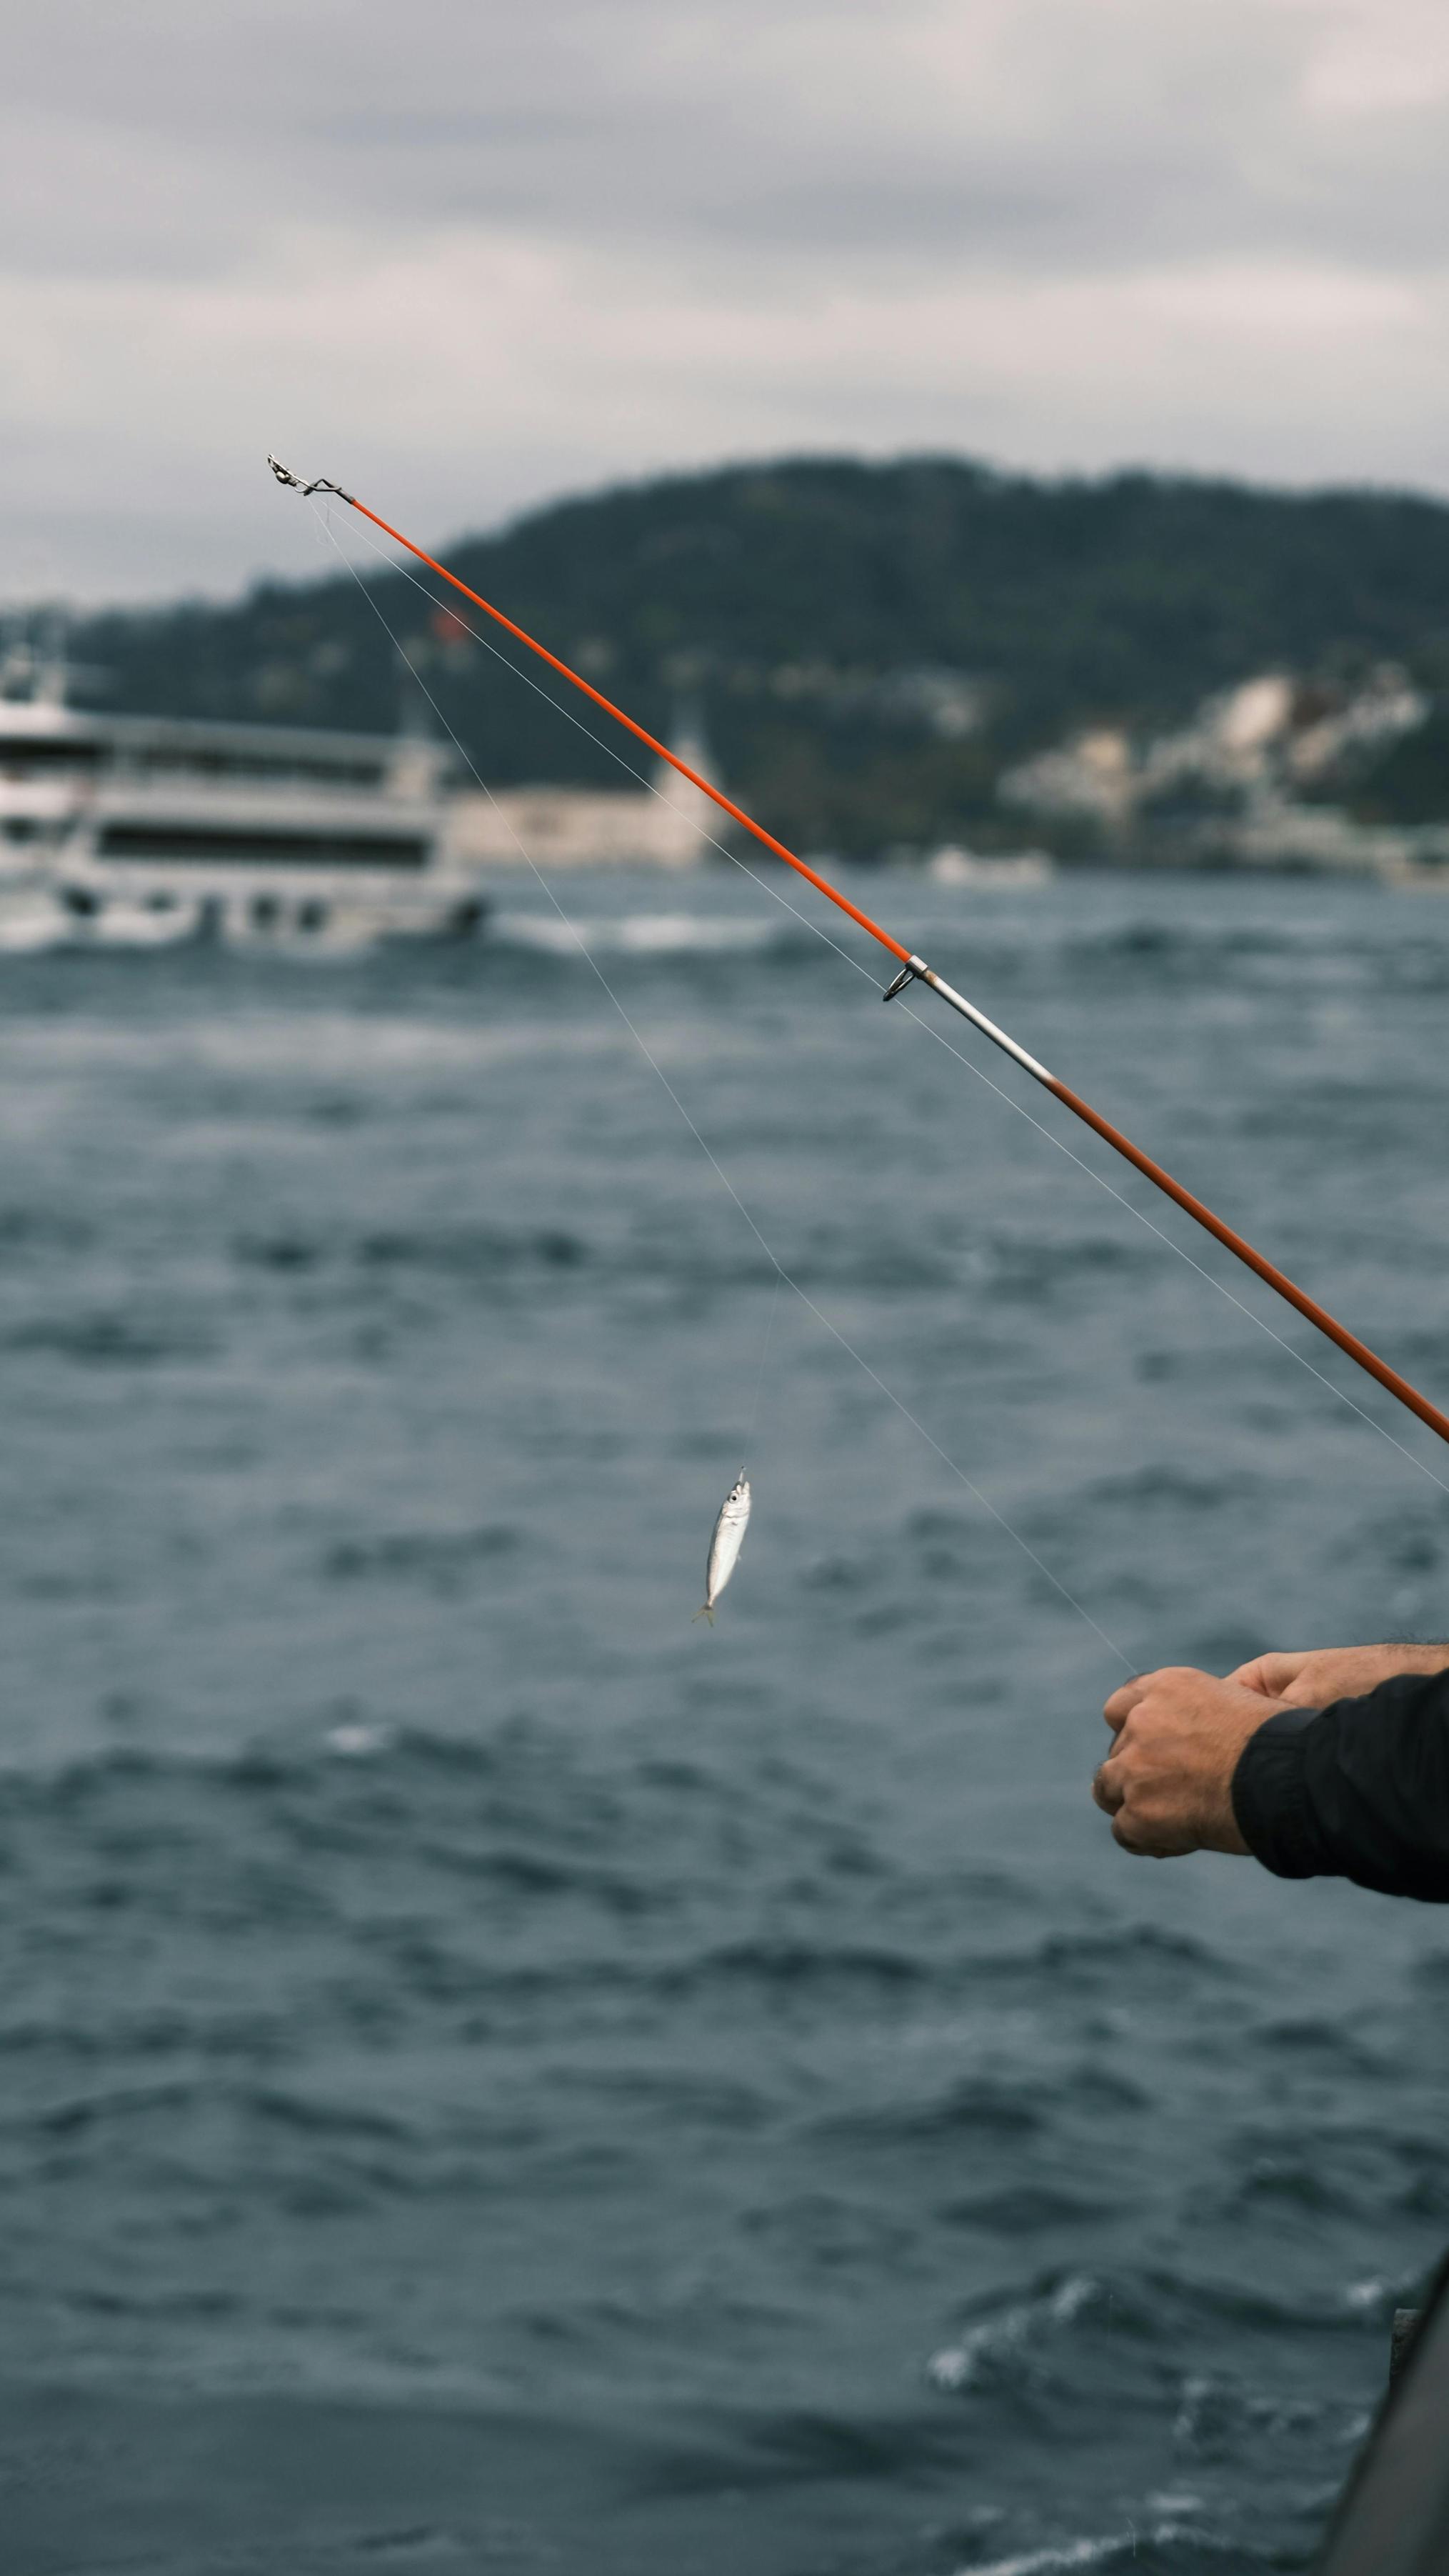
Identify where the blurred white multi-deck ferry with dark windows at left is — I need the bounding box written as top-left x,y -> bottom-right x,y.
0,652 -> 484,951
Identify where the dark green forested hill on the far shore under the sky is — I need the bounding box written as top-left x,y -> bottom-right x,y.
72,459 -> 1449,850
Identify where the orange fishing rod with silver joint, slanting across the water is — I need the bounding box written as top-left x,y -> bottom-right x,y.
268,456 -> 1449,1442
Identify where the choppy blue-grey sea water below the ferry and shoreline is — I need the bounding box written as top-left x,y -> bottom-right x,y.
0,876 -> 1449,2576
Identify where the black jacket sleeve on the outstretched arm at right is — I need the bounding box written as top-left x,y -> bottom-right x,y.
1233,1672 -> 1449,1904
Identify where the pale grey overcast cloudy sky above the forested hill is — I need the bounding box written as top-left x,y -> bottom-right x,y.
0,0 -> 1449,600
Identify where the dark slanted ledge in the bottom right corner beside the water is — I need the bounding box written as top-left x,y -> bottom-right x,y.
1315,2259 -> 1449,2576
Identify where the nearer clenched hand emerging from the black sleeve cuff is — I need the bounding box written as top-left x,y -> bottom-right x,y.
1091,1664 -> 1274,1860
